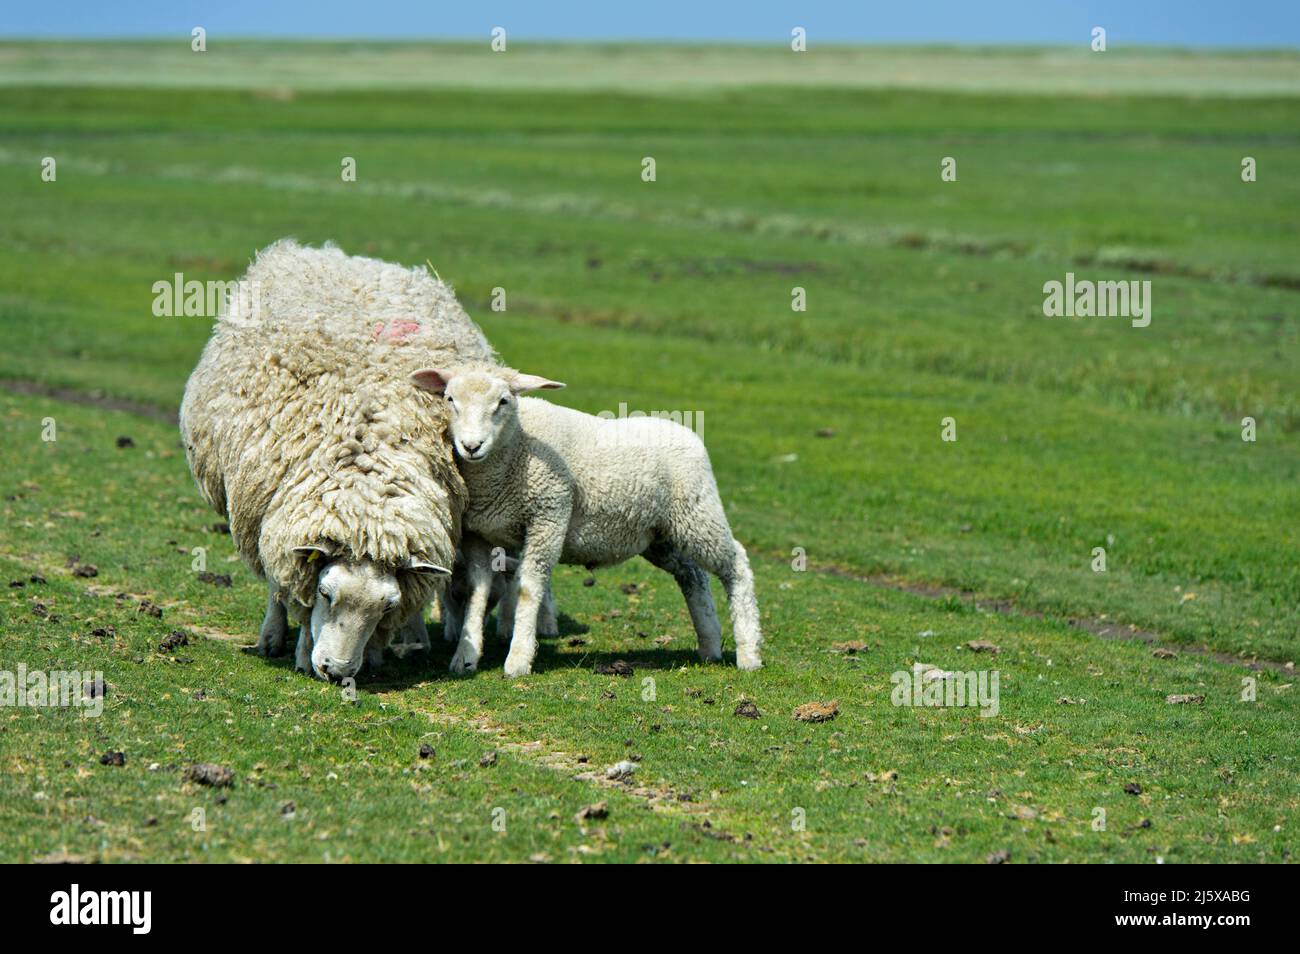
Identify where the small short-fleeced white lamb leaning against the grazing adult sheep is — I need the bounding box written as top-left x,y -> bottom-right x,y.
412,368 -> 762,677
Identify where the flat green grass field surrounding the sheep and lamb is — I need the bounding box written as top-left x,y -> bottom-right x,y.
0,43 -> 1300,862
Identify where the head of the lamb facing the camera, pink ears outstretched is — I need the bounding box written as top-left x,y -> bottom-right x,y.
411,368 -> 564,461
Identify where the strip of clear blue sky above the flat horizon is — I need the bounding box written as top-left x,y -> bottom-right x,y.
0,0 -> 1300,47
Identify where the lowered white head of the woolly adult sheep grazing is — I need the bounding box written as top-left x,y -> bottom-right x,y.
295,546 -> 450,682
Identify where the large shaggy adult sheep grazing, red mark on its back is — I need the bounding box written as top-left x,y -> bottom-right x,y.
181,239 -> 495,680
